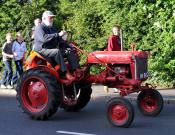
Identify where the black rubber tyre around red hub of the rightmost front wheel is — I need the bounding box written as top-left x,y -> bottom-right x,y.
137,89 -> 164,116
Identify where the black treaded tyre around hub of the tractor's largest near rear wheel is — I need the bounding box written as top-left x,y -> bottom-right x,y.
16,68 -> 61,120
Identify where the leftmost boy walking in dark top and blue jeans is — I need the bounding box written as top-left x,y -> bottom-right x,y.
1,33 -> 14,89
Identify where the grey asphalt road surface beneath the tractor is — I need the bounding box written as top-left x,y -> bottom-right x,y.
0,88 -> 175,135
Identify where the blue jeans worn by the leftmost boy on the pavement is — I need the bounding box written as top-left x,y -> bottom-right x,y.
1,60 -> 13,85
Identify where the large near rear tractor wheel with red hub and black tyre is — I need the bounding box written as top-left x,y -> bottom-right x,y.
16,68 -> 61,120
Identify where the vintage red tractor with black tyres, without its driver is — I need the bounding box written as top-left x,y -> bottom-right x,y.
16,44 -> 163,127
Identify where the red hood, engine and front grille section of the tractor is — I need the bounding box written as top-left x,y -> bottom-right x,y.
87,51 -> 148,87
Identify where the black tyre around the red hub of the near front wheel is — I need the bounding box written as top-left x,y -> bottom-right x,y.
106,97 -> 135,128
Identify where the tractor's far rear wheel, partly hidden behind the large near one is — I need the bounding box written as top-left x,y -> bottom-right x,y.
61,84 -> 92,112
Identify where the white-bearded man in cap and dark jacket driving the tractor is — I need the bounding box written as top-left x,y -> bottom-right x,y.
34,11 -> 79,81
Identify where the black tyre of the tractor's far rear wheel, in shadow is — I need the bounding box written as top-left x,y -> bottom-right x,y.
61,84 -> 92,112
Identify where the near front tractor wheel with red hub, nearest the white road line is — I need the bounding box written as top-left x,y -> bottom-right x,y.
106,97 -> 134,128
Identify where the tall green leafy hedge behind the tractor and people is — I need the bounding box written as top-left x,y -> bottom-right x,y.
0,0 -> 175,86
